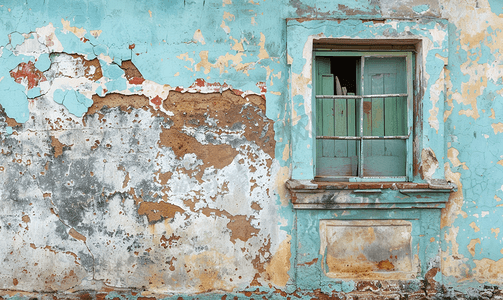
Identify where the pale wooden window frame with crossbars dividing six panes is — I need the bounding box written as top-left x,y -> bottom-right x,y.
312,49 -> 414,182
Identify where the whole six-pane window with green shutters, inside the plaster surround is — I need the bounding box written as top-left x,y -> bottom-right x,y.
313,49 -> 413,181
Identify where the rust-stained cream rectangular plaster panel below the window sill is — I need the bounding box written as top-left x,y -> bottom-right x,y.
320,220 -> 416,279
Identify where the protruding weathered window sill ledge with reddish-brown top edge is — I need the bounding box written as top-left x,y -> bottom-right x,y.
286,179 -> 456,210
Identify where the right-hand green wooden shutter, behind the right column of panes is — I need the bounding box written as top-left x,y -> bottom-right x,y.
363,57 -> 407,176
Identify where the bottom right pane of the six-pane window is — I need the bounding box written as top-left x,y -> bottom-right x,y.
363,139 -> 407,177
